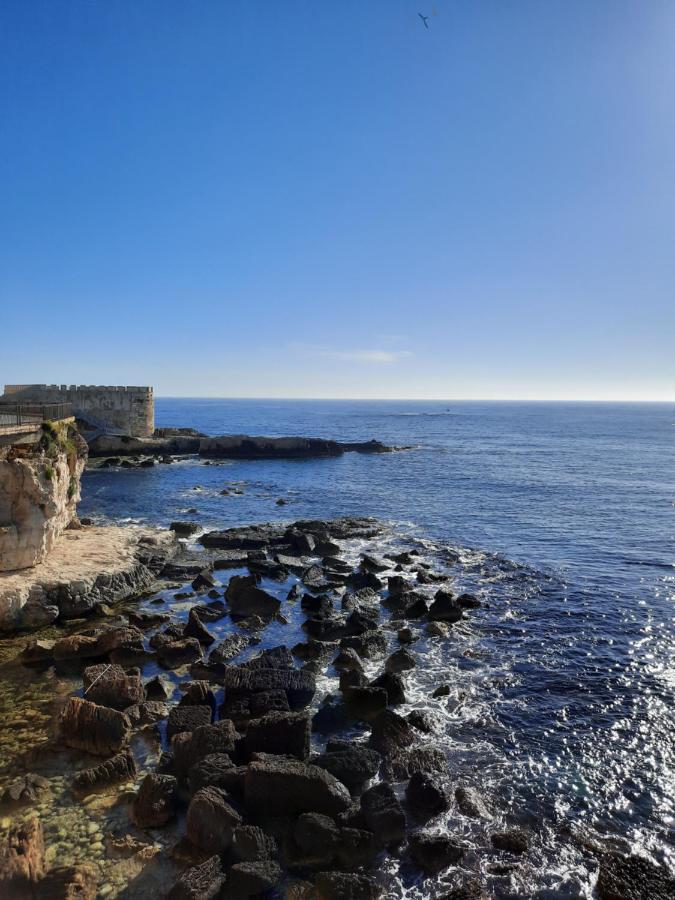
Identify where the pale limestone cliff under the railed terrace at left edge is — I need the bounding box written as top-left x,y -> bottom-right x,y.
0,422 -> 87,572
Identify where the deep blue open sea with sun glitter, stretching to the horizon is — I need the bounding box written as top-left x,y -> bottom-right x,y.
80,398 -> 675,897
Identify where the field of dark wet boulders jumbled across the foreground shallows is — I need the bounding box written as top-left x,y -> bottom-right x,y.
0,518 -> 673,900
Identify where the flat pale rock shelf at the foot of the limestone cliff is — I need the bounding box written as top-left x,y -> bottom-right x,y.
0,525 -> 177,631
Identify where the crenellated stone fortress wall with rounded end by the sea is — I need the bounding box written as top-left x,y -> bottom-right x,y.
2,384 -> 155,437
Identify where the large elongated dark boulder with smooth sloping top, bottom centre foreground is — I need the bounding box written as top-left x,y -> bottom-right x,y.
244,757 -> 351,816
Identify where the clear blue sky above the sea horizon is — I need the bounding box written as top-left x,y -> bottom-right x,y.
0,0 -> 675,399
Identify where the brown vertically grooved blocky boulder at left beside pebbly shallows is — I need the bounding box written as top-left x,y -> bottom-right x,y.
59,697 -> 131,756
